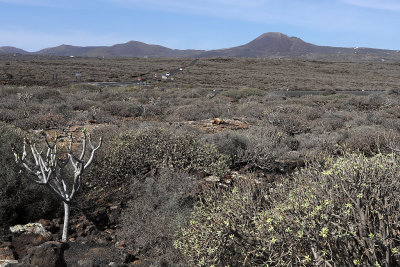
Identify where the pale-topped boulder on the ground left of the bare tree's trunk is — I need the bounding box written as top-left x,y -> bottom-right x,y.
10,223 -> 53,258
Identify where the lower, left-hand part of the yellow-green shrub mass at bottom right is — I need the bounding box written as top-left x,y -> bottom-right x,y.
174,182 -> 261,266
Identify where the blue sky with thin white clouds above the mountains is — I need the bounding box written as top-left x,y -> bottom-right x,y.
0,0 -> 400,51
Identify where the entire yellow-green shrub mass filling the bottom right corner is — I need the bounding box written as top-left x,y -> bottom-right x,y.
175,153 -> 400,266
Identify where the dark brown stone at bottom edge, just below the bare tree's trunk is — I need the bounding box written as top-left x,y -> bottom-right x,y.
22,241 -> 69,267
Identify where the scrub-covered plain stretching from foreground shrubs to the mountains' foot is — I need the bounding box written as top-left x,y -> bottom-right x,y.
0,56 -> 400,266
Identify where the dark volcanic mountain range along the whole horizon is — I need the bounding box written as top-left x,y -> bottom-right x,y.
0,32 -> 400,61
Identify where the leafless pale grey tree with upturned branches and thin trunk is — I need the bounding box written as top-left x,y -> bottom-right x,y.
12,130 -> 102,242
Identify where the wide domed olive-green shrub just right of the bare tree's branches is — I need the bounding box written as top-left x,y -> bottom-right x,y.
87,127 -> 227,188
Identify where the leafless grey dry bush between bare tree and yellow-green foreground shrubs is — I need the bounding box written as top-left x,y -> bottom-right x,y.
117,169 -> 196,266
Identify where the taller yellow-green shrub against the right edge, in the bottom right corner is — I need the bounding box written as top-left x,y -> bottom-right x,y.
255,154 -> 400,266
